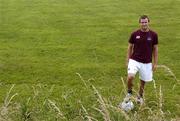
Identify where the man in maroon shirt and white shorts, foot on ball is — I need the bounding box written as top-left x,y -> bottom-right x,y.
124,15 -> 158,104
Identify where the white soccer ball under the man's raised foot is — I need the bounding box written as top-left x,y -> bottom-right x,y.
121,100 -> 134,111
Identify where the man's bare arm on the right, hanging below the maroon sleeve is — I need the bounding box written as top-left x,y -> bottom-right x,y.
152,44 -> 158,71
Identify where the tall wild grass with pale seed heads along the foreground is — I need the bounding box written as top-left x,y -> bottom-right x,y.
0,66 -> 180,121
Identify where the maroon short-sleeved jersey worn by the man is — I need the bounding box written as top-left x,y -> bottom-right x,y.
129,29 -> 158,63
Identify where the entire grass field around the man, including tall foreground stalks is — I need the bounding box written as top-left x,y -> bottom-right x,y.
0,0 -> 180,121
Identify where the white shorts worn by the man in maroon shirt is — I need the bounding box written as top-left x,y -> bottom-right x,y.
128,59 -> 153,82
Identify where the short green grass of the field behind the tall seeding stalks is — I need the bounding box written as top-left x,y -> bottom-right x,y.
0,0 -> 180,118
